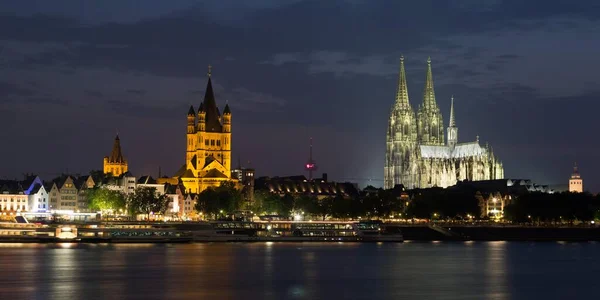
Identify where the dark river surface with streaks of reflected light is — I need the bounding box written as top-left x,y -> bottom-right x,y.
0,242 -> 600,300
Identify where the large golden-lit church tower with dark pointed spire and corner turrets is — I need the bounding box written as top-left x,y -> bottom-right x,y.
175,67 -> 237,193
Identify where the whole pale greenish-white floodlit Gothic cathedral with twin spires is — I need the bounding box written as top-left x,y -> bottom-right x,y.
384,57 -> 504,189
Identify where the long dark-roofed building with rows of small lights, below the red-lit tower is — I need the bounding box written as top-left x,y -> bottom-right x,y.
254,174 -> 359,199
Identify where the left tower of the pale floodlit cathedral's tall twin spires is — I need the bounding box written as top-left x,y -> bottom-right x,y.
384,56 -> 417,188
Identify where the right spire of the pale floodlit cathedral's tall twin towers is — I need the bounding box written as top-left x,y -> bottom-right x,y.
417,58 -> 445,146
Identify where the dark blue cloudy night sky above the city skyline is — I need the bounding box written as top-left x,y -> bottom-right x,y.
0,0 -> 600,192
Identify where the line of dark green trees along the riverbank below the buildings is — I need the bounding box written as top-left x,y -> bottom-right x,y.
88,178 -> 600,222
